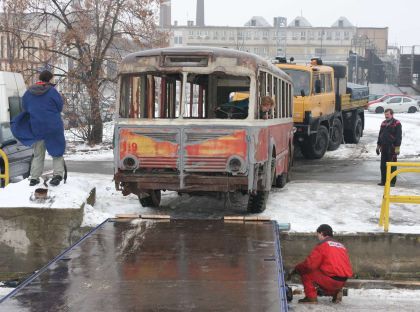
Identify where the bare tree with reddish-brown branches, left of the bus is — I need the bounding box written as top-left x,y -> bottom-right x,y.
27,0 -> 166,144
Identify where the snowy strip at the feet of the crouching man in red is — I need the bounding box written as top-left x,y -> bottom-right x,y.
289,289 -> 420,312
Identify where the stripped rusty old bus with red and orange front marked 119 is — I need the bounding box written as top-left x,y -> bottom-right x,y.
114,47 -> 293,212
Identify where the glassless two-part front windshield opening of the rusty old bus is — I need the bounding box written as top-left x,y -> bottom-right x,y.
119,72 -> 251,119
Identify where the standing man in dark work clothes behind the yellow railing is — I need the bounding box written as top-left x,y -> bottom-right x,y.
376,108 -> 402,186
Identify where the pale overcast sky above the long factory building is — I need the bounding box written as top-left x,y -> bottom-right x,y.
172,0 -> 420,46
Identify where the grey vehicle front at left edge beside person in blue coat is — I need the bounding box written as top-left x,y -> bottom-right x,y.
0,122 -> 33,184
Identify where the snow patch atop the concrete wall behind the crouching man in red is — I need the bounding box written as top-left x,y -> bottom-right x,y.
263,182 -> 420,233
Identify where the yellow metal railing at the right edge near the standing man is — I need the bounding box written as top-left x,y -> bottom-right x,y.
379,162 -> 420,232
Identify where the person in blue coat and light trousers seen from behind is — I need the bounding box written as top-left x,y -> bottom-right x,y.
11,70 -> 66,186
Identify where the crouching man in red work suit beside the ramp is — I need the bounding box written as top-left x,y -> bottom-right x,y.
293,224 -> 353,303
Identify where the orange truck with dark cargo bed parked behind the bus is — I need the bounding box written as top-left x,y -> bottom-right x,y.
276,58 -> 369,159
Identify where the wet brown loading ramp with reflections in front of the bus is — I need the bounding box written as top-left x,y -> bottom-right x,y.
0,218 -> 288,312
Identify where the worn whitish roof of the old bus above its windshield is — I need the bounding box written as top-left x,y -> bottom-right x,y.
120,46 -> 291,82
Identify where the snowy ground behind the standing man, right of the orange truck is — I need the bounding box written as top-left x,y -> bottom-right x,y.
324,111 -> 420,161
